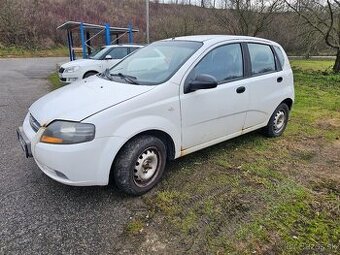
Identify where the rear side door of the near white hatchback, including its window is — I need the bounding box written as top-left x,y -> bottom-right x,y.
244,43 -> 286,129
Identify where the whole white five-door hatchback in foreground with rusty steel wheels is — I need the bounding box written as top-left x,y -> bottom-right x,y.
17,35 -> 294,195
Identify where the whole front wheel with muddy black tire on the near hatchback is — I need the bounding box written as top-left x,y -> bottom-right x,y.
113,135 -> 167,195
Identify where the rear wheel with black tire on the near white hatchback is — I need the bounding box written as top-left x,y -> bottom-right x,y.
263,103 -> 289,137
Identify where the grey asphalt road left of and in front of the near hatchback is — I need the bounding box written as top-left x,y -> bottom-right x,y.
0,58 -> 141,254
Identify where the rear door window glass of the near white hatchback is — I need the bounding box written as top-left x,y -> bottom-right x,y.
248,43 -> 276,75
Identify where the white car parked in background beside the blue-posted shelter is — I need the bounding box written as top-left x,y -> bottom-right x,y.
58,44 -> 143,83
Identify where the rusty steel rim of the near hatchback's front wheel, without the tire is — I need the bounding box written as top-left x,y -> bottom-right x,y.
133,148 -> 160,187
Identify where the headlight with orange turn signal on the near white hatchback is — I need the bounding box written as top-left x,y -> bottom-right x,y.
40,120 -> 95,144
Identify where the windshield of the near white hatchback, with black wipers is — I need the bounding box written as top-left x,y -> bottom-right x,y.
110,40 -> 202,85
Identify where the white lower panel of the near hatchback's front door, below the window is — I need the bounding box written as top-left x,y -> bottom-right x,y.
181,78 -> 249,149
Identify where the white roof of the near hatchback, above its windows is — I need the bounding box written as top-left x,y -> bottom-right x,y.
165,35 -> 275,44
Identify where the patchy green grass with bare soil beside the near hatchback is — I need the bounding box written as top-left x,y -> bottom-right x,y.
133,60 -> 340,254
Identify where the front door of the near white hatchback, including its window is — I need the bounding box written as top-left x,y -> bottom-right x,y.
180,43 -> 249,151
